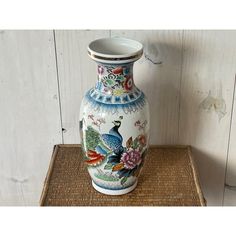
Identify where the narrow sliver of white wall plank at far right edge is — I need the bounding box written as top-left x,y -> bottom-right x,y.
224,77 -> 236,206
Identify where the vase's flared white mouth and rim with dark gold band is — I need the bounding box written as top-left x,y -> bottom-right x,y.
88,37 -> 143,64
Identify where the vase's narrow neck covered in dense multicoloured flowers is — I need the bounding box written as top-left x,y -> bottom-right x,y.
95,62 -> 135,96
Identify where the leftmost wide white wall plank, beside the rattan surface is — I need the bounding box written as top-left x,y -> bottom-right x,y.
0,31 -> 62,205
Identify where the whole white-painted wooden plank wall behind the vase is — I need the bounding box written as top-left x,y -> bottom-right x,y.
0,30 -> 236,205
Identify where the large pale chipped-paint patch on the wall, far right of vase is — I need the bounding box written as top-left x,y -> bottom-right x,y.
199,90 -> 227,121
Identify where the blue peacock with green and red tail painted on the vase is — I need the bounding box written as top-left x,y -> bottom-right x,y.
84,117 -> 124,166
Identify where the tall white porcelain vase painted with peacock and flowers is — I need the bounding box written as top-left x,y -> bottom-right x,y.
80,37 -> 150,195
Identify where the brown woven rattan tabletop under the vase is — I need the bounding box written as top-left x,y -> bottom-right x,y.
40,145 -> 205,206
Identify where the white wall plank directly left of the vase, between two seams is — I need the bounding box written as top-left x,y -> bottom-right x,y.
56,30 -> 109,143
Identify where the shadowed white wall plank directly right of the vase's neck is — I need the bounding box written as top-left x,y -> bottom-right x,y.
111,30 -> 183,144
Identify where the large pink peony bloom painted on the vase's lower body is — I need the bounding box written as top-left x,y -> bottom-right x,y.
120,149 -> 142,170
